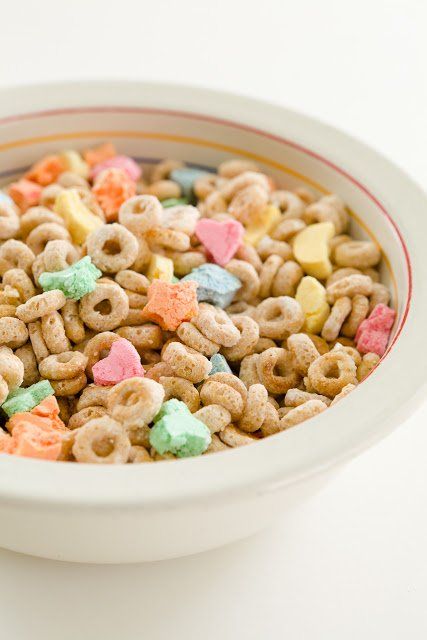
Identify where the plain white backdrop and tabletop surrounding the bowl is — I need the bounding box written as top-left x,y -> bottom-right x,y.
0,0 -> 427,640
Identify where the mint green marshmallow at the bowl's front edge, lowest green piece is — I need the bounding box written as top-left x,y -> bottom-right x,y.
150,399 -> 212,458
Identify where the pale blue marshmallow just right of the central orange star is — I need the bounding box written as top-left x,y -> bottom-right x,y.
181,264 -> 242,309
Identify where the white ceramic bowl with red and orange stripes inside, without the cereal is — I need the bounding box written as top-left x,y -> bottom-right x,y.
0,82 -> 427,562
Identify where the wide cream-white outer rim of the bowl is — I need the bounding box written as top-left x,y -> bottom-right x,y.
0,79 -> 427,509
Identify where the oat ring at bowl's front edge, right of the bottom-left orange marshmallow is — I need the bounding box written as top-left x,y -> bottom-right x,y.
72,416 -> 131,464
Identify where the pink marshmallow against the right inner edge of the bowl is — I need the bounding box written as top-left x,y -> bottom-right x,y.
355,304 -> 396,356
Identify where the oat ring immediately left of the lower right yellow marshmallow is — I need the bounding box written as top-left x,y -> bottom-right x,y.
255,296 -> 305,340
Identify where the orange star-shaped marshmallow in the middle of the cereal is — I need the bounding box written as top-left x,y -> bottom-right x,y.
141,280 -> 199,331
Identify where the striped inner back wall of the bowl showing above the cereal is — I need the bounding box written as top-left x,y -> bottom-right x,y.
0,107 -> 409,344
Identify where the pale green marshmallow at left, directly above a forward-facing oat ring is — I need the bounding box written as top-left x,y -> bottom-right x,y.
39,256 -> 102,300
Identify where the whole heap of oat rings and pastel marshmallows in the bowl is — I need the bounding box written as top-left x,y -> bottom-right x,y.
0,144 -> 395,464
